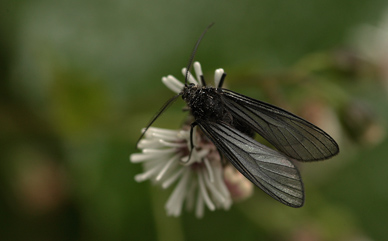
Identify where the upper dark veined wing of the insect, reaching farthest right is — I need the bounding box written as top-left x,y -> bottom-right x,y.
221,89 -> 339,161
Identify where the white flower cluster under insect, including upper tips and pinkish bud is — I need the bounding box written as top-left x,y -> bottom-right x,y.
130,62 -> 253,218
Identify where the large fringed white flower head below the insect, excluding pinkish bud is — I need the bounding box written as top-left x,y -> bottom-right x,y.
130,127 -> 232,217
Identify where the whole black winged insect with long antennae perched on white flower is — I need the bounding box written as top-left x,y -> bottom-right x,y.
140,25 -> 339,207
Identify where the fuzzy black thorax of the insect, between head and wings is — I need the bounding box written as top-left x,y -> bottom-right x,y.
182,85 -> 231,123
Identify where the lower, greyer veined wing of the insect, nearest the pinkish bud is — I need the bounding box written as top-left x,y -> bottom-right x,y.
196,120 -> 304,207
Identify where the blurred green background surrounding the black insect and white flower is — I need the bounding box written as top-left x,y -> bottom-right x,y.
0,0 -> 388,241
